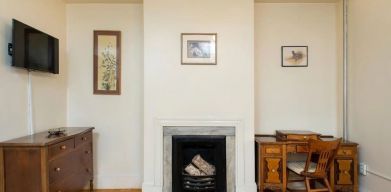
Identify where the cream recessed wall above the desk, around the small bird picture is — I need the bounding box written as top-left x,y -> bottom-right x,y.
255,3 -> 342,135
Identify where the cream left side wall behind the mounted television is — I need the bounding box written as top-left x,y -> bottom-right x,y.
0,0 -> 67,140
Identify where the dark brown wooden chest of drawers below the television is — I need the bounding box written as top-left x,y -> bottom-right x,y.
0,127 -> 94,192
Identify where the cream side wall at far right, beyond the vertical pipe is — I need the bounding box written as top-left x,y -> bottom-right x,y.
349,0 -> 391,192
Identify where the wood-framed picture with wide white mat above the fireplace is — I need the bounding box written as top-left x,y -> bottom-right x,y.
181,33 -> 217,65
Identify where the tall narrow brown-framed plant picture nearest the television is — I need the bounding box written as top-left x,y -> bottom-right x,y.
94,31 -> 121,95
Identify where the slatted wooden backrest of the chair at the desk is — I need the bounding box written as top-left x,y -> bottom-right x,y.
304,139 -> 341,178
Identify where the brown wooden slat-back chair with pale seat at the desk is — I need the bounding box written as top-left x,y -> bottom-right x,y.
287,139 -> 341,192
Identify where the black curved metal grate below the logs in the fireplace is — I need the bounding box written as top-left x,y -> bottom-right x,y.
182,172 -> 216,192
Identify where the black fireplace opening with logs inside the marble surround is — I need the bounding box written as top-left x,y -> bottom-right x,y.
172,135 -> 227,192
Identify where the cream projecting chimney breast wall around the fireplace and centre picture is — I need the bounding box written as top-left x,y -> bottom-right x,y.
143,0 -> 255,192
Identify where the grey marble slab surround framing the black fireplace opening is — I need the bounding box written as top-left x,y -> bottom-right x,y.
163,126 -> 236,192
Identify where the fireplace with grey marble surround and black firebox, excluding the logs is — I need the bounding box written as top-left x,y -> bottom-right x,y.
162,126 -> 236,192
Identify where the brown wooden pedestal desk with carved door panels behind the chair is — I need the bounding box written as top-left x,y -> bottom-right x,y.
255,131 -> 358,192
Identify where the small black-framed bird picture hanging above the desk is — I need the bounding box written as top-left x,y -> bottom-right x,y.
281,46 -> 308,67
